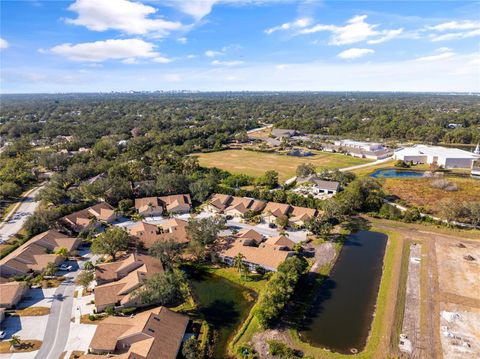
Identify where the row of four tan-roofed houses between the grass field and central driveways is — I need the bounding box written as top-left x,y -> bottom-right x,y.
204,194 -> 317,226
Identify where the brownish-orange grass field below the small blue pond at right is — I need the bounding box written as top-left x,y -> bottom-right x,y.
384,177 -> 480,214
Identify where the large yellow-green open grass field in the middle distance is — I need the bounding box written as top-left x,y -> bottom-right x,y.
196,150 -> 372,181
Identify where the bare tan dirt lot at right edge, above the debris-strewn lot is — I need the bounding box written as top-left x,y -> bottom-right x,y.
435,239 -> 480,304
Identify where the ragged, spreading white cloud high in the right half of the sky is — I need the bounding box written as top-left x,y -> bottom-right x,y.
285,15 -> 403,45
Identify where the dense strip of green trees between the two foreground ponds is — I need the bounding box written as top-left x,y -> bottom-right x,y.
255,256 -> 308,328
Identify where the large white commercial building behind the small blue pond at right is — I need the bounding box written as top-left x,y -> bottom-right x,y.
393,145 -> 480,168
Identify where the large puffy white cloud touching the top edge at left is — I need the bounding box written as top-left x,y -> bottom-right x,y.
66,0 -> 183,36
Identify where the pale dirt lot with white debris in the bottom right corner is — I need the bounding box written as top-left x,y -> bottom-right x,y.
440,304 -> 480,359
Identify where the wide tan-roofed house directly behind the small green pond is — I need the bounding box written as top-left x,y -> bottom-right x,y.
220,239 -> 293,271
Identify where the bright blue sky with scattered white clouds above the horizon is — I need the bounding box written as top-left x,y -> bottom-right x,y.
0,0 -> 480,93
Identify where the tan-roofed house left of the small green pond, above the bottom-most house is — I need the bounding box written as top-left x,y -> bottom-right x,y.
94,253 -> 163,312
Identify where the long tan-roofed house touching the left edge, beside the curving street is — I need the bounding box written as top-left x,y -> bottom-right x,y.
0,230 -> 81,277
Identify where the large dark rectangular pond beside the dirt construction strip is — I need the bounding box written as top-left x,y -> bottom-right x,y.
300,231 -> 388,354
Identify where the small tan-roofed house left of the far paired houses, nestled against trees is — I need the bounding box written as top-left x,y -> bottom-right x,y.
62,202 -> 118,232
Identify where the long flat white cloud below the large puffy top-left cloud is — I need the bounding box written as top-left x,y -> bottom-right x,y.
50,39 -> 160,63
